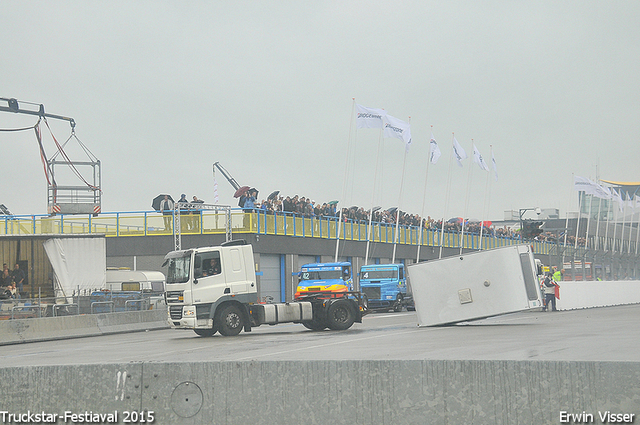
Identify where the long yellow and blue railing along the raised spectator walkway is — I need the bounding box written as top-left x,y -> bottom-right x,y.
0,208 -> 616,257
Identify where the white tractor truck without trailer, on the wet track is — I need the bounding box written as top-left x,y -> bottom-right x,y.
165,240 -> 364,336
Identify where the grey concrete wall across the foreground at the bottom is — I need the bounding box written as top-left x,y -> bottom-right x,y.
0,360 -> 640,425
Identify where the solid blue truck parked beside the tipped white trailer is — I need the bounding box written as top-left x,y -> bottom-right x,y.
360,264 -> 414,311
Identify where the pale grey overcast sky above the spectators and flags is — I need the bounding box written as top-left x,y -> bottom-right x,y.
0,0 -> 640,220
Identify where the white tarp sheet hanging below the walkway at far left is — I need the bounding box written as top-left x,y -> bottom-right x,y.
43,237 -> 107,296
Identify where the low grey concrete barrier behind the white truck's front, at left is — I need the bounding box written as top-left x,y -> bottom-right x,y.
0,309 -> 169,345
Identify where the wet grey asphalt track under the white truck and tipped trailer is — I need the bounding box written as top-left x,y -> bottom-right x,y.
0,305 -> 640,366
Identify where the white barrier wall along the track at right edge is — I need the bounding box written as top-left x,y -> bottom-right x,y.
556,280 -> 640,310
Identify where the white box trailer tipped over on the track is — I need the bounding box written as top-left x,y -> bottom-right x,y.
407,245 -> 542,326
